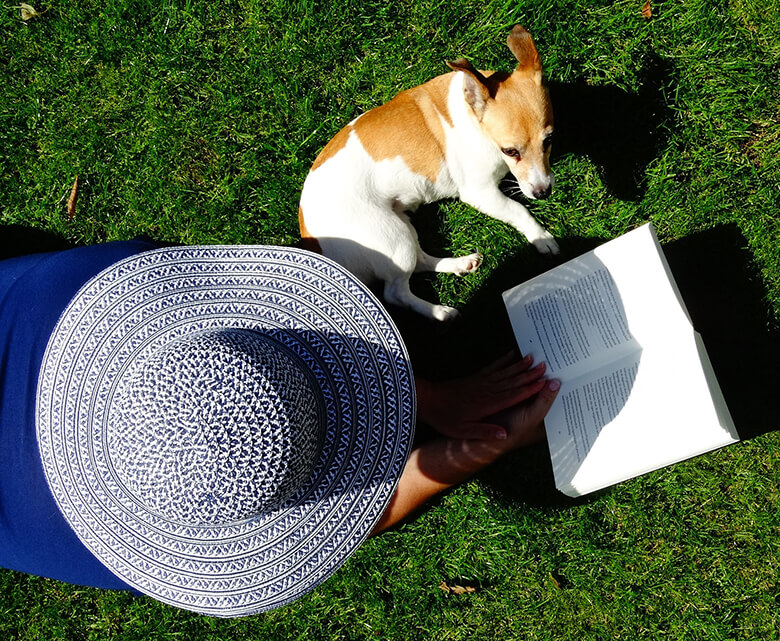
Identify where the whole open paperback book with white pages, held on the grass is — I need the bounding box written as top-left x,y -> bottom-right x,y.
504,224 -> 739,496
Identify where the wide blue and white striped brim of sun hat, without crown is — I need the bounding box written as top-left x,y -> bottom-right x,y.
37,246 -> 416,616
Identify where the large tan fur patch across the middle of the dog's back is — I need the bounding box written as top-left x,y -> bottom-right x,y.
354,74 -> 452,182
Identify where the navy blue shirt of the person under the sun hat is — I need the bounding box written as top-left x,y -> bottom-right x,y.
0,240 -> 156,589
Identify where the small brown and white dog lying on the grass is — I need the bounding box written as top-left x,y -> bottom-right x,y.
298,25 -> 558,320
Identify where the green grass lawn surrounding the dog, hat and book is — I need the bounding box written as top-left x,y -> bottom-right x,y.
0,0 -> 780,641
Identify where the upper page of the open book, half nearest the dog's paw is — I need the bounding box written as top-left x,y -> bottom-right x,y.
504,224 -> 690,381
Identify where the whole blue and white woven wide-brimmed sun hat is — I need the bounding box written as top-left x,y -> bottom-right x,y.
37,246 -> 416,617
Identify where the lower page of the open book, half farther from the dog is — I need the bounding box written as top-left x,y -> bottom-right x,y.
545,332 -> 739,496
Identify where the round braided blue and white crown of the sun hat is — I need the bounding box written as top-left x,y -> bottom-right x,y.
107,329 -> 323,525
